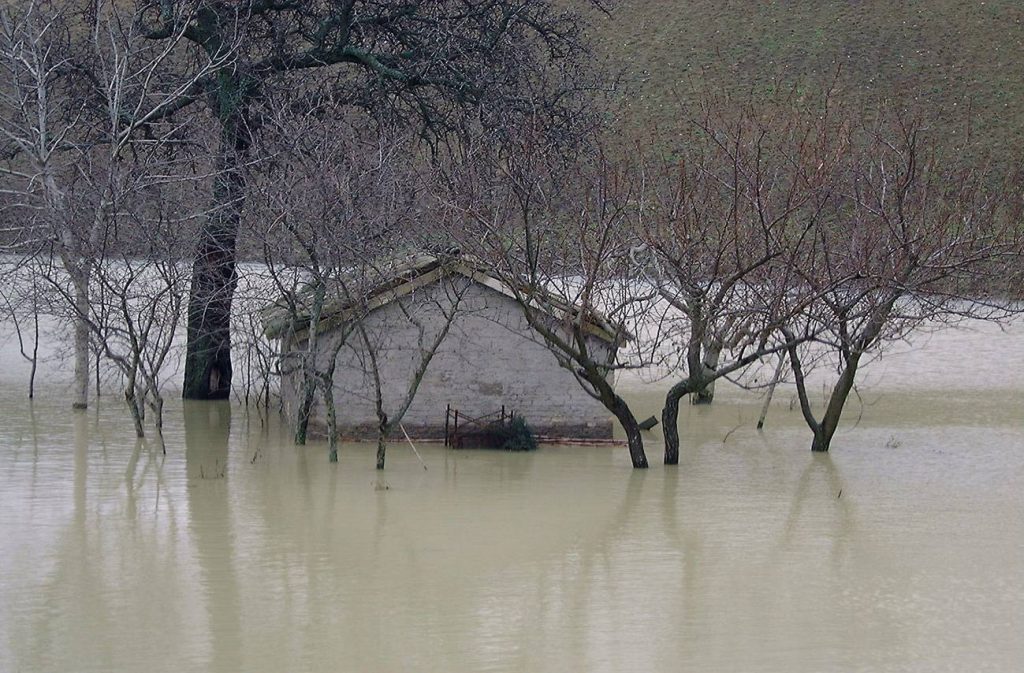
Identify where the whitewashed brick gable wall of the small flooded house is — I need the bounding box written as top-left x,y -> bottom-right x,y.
282,277 -> 611,437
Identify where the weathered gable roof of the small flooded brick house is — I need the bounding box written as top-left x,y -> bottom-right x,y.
261,250 -> 628,343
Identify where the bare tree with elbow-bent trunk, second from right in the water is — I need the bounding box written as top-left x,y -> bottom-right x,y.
632,99 -> 845,465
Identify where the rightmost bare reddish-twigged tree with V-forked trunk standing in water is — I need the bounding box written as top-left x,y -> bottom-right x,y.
785,110 -> 1021,451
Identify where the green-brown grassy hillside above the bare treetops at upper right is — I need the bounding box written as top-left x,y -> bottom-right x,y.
589,0 -> 1024,152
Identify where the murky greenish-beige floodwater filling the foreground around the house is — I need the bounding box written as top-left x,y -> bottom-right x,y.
0,315 -> 1024,672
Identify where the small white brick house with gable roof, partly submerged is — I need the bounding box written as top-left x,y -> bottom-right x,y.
264,253 -> 621,440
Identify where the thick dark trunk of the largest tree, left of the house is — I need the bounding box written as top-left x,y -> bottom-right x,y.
182,112 -> 249,399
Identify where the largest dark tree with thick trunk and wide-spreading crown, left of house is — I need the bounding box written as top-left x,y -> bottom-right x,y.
131,0 -> 602,398
